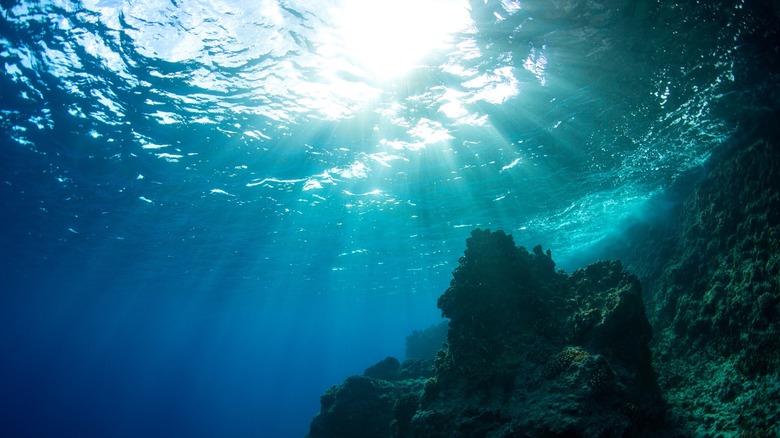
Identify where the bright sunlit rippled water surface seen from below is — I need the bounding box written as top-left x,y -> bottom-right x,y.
0,0 -> 739,266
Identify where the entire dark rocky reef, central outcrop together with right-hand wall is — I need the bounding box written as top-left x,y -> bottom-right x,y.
309,134 -> 780,438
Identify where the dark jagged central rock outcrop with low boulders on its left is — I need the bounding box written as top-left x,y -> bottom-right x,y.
310,229 -> 663,438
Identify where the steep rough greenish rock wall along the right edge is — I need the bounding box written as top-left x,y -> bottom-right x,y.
648,137 -> 780,436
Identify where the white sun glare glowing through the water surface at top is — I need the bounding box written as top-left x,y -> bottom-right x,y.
334,0 -> 471,79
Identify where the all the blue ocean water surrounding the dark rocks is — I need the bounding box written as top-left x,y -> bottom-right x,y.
0,0 -> 780,437
